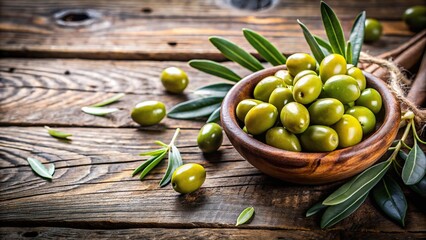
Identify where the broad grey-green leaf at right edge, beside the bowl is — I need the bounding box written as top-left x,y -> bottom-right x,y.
401,141 -> 426,185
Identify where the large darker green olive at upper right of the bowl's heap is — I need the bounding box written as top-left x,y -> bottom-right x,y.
324,75 -> 360,104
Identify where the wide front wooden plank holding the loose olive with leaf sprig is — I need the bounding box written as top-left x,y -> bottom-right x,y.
0,127 -> 426,233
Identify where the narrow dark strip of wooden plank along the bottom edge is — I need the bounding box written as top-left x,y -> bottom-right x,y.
0,227 -> 426,240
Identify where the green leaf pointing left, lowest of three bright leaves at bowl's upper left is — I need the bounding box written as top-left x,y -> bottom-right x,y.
188,59 -> 241,82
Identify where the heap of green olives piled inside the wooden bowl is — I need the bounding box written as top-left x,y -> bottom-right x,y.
236,53 -> 382,152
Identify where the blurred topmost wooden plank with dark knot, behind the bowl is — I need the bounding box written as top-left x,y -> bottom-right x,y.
0,0 -> 423,60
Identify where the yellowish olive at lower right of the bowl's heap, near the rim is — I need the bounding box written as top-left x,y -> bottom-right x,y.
332,114 -> 362,148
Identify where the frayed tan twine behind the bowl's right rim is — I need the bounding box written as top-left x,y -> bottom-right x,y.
359,52 -> 426,131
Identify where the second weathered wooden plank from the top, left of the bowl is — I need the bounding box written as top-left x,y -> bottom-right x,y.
0,59 -> 249,128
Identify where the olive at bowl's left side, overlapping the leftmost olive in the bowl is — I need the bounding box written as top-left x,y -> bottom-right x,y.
244,103 -> 278,135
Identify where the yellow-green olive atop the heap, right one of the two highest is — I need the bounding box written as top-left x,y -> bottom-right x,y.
320,54 -> 346,83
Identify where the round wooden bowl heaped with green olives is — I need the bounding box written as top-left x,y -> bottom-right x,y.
221,54 -> 401,184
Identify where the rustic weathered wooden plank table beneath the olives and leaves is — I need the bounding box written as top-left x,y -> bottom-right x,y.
0,0 -> 426,239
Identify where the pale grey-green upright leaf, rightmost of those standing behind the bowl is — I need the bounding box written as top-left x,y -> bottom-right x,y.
349,11 -> 366,67
